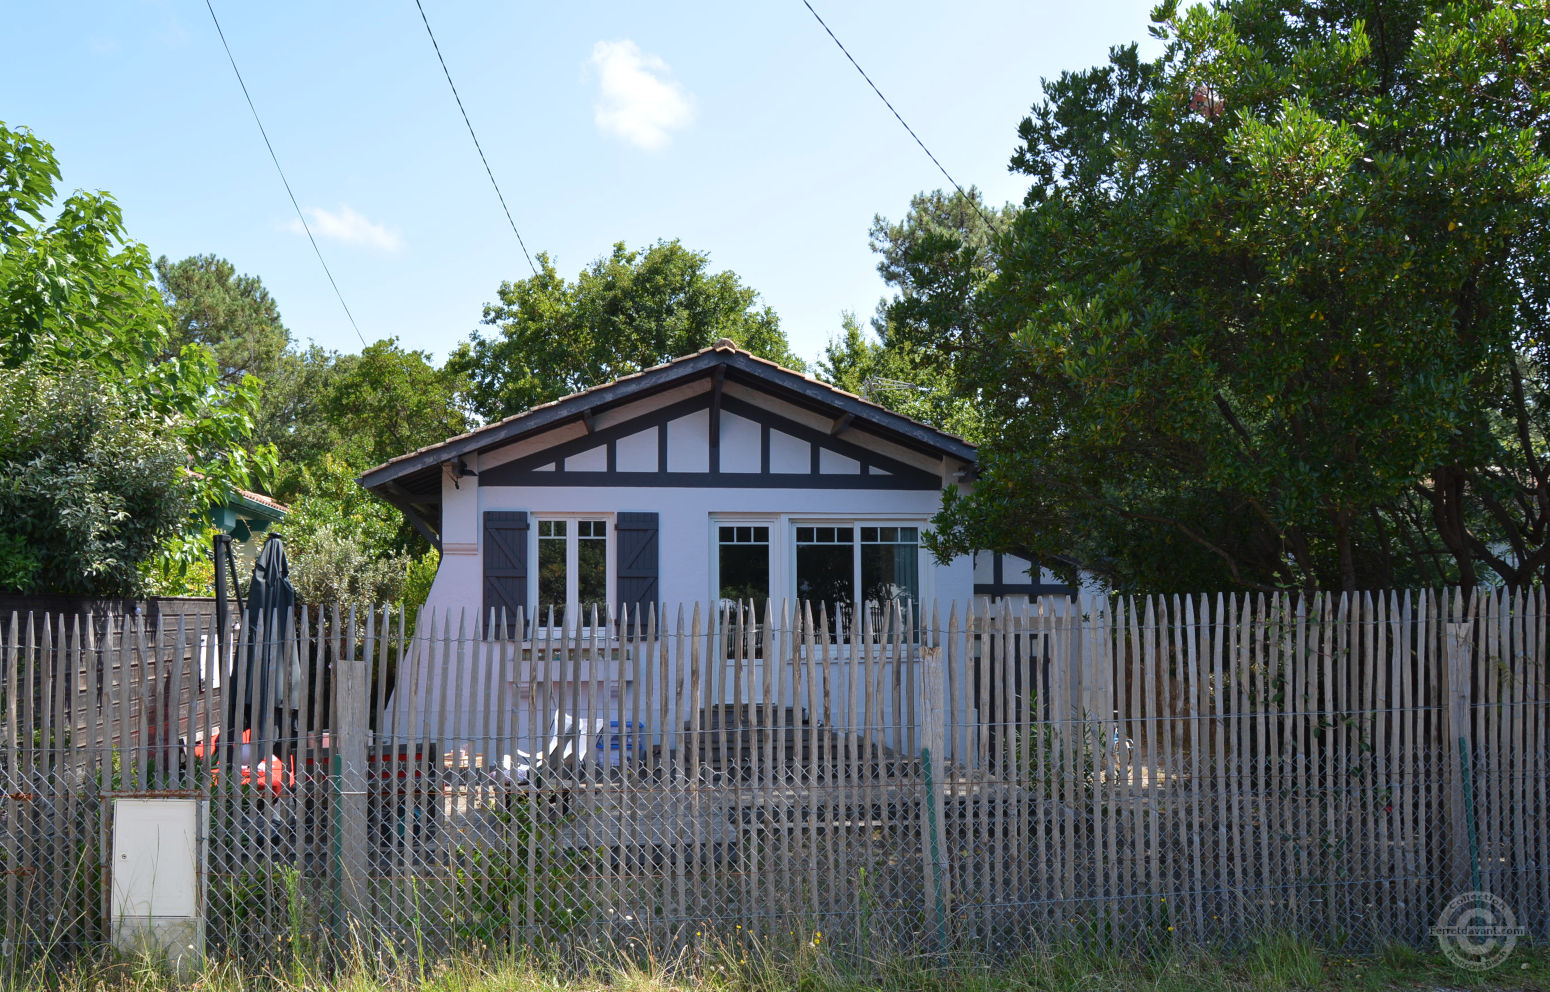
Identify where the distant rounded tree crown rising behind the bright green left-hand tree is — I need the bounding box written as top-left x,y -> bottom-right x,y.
157,254 -> 290,384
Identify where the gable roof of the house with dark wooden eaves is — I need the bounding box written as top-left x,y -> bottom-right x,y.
360,338 -> 978,539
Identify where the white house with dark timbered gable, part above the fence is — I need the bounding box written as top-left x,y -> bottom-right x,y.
361,341 -> 979,625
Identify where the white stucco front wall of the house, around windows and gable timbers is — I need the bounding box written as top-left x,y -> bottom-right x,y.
394,395 -> 975,761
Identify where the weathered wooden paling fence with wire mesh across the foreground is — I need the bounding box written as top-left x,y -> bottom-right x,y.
0,591 -> 1550,958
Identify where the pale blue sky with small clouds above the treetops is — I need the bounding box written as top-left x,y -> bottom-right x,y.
0,0 -> 1153,370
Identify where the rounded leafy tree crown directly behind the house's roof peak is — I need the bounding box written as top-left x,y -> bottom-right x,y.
448,240 -> 801,420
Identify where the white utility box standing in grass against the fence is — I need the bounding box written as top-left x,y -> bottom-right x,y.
109,797 -> 208,970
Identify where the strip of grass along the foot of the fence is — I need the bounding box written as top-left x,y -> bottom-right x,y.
0,938 -> 1550,992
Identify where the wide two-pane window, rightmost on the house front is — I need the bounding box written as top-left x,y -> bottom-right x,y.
797,525 -> 921,623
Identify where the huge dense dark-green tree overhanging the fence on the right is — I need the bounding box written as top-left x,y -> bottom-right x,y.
908,0 -> 1550,589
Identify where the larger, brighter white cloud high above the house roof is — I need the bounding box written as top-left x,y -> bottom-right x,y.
587,40 -> 694,152
